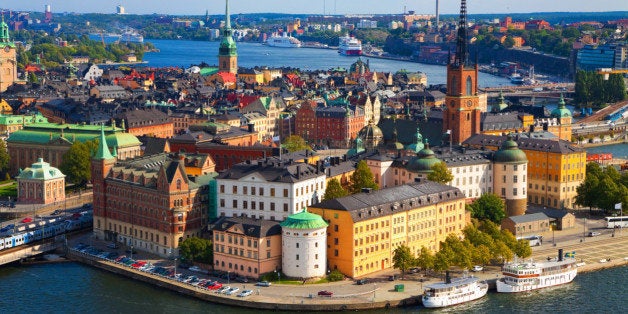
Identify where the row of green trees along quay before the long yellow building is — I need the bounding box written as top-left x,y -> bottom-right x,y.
393,220 -> 532,273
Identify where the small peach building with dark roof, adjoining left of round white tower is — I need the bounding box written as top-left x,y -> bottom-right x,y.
211,217 -> 282,278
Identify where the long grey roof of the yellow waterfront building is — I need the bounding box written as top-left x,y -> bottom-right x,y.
312,181 -> 465,222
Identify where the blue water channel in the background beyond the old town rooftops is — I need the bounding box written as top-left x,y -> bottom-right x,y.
144,39 -> 512,87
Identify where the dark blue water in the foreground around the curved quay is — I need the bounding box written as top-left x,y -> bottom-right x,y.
0,263 -> 628,314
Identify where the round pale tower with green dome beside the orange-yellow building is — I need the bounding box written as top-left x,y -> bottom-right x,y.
493,136 -> 528,216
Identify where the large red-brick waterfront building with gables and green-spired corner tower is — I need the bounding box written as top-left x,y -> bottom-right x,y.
92,125 -> 215,257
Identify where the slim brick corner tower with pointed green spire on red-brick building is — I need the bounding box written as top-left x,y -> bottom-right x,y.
91,125 -> 117,240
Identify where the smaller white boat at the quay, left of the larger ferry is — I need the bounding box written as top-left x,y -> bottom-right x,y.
422,272 -> 488,308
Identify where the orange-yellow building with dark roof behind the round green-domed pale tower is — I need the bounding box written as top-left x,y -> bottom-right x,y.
465,133 -> 587,208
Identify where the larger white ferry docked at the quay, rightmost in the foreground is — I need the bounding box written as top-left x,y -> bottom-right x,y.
497,249 -> 578,293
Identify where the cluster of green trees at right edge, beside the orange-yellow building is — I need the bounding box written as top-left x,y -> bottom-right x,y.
576,162 -> 628,214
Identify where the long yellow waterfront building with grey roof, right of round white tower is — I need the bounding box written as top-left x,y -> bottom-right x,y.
309,181 -> 469,278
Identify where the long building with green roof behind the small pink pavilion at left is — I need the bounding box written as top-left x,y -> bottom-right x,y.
6,123 -> 142,175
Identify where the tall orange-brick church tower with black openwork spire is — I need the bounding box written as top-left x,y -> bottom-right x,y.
443,0 -> 481,144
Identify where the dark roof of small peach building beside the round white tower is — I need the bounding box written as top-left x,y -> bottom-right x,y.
212,217 -> 281,238
